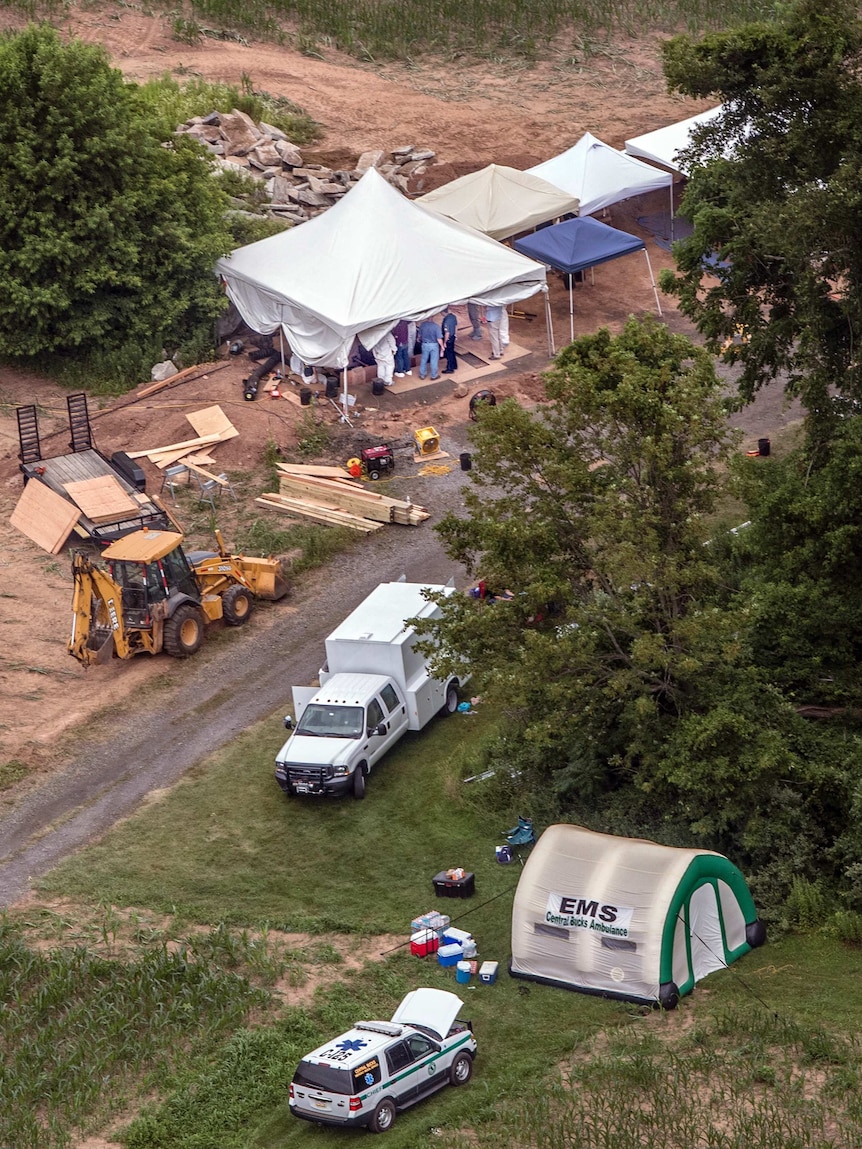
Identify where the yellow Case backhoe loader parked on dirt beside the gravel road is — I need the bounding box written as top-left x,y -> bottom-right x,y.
69,529 -> 287,666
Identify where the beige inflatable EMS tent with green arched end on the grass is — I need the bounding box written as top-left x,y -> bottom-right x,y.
509,825 -> 765,1009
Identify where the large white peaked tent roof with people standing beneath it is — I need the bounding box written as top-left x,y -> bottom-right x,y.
216,169 -> 545,367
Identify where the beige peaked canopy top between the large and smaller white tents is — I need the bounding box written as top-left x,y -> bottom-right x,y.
415,163 -> 578,239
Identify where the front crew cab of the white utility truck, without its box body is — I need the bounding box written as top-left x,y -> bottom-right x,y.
276,674 -> 408,797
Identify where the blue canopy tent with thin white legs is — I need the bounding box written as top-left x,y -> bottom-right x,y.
513,216 -> 662,339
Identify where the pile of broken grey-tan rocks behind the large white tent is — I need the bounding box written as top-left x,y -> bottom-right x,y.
177,108 -> 434,223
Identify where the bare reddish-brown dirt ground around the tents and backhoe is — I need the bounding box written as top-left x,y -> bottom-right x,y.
0,3 -> 798,801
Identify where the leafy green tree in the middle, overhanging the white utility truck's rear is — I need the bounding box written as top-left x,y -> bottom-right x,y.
425,319 -> 738,808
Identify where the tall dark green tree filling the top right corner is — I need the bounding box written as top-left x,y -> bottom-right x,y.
662,0 -> 862,422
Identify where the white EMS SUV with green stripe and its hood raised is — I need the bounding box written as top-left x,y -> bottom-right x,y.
290,989 -> 476,1133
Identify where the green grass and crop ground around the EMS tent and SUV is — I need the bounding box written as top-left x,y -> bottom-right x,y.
0,708 -> 862,1149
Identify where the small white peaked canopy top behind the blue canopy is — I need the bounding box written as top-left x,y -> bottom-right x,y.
528,132 -> 674,216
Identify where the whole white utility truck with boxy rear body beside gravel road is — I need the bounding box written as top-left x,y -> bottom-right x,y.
276,583 -> 467,799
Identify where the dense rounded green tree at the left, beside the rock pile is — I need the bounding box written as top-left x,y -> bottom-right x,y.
0,25 -> 230,356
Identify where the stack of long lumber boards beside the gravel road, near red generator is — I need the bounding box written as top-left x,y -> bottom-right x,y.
255,463 -> 429,534
